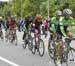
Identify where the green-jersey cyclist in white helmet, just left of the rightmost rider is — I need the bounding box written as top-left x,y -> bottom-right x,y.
48,10 -> 62,65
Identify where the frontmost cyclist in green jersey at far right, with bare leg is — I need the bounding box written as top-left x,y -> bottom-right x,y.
57,9 -> 75,66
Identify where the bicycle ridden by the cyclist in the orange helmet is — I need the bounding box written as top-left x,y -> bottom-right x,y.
32,29 -> 45,57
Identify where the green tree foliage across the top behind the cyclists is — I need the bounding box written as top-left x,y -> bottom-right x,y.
0,0 -> 75,18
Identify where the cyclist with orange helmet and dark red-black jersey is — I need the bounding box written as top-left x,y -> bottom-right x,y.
32,15 -> 42,48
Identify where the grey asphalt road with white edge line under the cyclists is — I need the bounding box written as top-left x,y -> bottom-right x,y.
0,32 -> 75,66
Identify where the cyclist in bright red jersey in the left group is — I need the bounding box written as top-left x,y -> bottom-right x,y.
9,16 -> 17,45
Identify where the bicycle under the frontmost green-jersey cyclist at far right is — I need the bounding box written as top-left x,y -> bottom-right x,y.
54,38 -> 75,66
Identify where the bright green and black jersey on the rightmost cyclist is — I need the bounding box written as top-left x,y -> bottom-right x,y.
60,17 -> 75,37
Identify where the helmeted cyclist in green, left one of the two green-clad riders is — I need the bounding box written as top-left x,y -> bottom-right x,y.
48,10 -> 62,40
